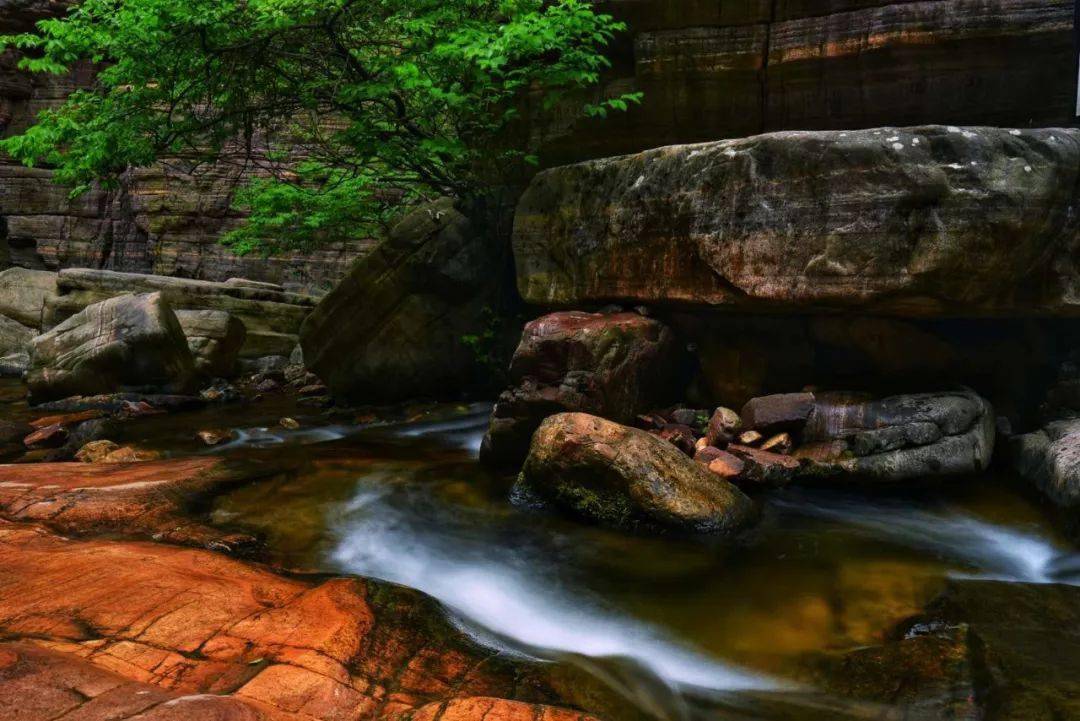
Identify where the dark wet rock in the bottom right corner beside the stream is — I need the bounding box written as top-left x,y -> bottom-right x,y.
816,581 -> 1080,719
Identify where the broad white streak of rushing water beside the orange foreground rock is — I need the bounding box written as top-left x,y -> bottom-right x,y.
334,487 -> 779,692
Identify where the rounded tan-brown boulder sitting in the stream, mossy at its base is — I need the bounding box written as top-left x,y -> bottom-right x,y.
521,413 -> 756,534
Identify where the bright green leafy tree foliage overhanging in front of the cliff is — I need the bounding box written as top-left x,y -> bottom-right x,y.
0,0 -> 639,251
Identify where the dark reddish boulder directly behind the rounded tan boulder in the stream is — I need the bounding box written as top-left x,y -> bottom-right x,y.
481,312 -> 675,465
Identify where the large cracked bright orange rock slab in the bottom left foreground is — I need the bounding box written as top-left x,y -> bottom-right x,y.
0,521 -> 588,721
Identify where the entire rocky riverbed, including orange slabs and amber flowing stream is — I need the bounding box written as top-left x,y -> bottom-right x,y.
0,371 -> 1080,721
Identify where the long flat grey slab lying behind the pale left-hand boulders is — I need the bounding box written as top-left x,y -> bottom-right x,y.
44,268 -> 315,358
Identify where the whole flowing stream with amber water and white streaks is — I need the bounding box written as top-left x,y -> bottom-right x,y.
4,382 -> 1080,719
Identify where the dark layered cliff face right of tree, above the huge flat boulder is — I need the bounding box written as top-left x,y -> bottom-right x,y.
544,0 -> 1076,164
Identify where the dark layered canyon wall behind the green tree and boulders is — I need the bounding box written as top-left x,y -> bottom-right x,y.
0,0 -> 1076,291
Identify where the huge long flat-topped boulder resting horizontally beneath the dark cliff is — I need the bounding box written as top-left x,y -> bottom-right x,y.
513,125 -> 1080,316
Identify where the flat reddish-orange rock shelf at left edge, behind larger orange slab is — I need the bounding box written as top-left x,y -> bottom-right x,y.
0,457 -> 265,548
